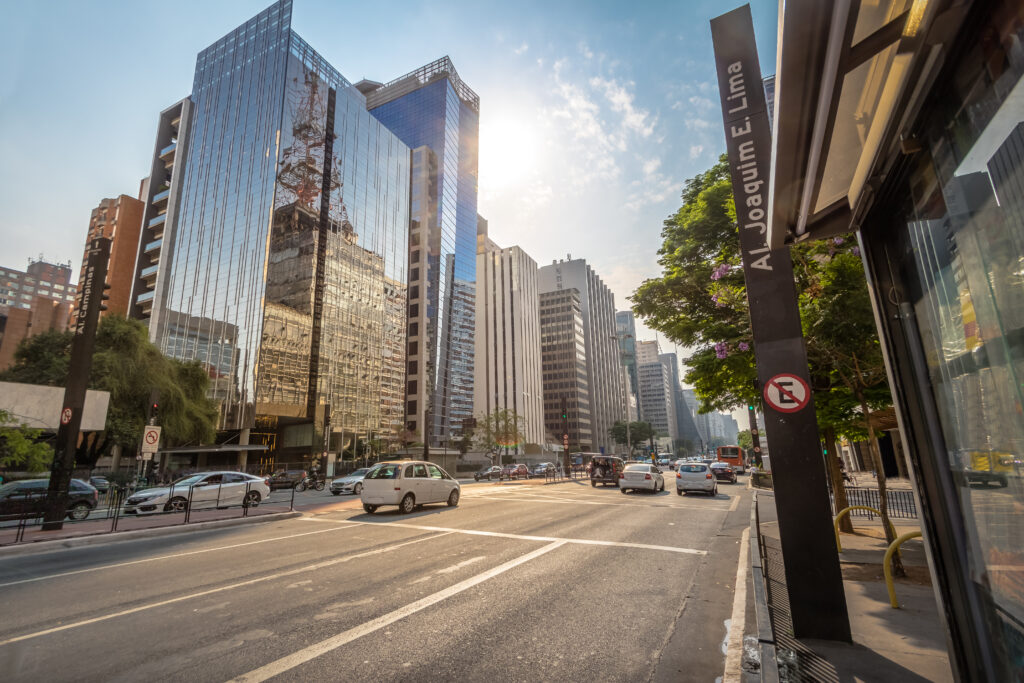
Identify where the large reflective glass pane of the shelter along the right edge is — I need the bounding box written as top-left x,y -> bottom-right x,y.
900,2 -> 1024,674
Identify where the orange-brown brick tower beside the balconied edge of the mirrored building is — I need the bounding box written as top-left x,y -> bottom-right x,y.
73,195 -> 145,325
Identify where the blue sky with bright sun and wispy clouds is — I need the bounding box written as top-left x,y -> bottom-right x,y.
0,0 -> 778,421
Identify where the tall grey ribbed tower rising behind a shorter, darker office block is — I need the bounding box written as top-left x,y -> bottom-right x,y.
538,257 -> 626,453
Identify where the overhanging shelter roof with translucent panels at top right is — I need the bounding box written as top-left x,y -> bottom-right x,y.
768,0 -> 971,248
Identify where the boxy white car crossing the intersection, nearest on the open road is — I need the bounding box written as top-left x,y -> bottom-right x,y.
359,460 -> 462,514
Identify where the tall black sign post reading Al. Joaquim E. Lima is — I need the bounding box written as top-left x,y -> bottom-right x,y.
711,5 -> 850,642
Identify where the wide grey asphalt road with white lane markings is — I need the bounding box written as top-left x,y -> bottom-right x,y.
0,477 -> 753,682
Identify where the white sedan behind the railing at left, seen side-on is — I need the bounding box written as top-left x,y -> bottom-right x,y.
124,472 -> 270,515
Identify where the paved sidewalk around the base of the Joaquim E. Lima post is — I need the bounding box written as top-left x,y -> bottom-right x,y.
757,490 -> 953,683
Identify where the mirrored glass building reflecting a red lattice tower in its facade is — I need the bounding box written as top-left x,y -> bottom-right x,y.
135,0 -> 411,460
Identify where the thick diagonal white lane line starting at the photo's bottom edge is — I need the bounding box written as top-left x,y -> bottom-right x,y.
228,541 -> 565,683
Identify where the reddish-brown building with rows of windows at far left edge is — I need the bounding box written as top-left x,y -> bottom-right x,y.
0,258 -> 75,370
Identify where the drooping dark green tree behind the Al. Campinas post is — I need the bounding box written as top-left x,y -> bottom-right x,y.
0,315 -> 217,467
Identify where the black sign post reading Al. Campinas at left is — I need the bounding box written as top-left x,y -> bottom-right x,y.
43,238 -> 111,530
